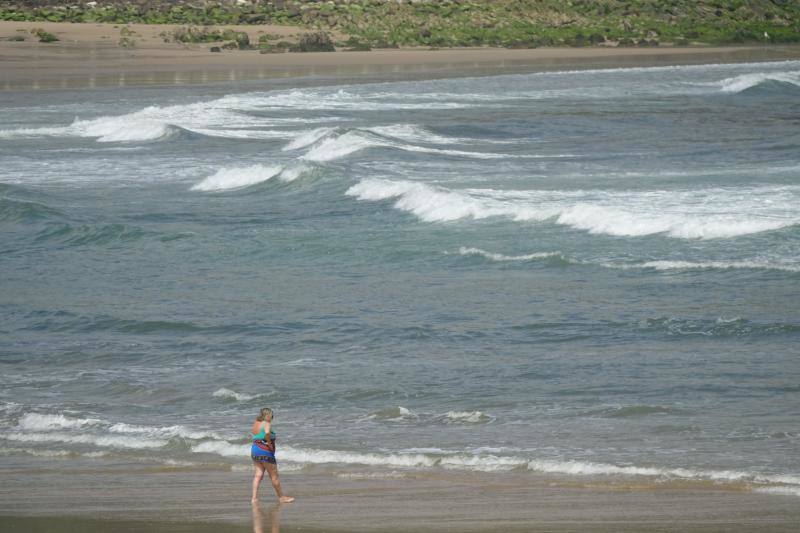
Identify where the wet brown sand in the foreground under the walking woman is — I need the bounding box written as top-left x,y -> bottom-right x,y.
0,461 -> 800,533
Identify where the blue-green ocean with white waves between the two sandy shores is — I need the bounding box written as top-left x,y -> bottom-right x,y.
0,61 -> 800,496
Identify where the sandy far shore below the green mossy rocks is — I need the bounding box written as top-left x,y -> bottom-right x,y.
0,22 -> 800,91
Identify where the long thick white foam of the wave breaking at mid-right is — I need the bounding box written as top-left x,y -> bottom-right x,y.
346,178 -> 800,239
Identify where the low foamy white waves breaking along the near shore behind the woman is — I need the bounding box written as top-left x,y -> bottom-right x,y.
0,412 -> 800,495
